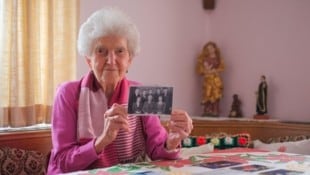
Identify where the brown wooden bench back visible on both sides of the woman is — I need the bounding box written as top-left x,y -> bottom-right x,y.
0,117 -> 310,154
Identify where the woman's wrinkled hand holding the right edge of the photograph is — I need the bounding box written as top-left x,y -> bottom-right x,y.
166,110 -> 193,150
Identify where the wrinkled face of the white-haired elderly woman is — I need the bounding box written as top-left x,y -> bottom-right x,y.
86,35 -> 132,86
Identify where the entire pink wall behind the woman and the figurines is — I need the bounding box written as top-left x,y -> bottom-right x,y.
77,0 -> 310,121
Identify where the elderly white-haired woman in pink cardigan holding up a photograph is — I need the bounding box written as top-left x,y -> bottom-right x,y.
48,8 -> 193,174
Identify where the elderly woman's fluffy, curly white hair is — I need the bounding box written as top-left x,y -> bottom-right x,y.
77,8 -> 140,57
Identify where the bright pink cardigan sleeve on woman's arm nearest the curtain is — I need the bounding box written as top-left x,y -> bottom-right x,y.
50,84 -> 98,172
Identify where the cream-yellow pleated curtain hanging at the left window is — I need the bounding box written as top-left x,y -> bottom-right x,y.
0,0 -> 79,127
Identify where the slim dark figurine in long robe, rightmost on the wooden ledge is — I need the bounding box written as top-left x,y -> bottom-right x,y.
254,75 -> 269,119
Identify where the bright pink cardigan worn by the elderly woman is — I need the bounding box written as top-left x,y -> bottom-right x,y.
48,72 -> 179,174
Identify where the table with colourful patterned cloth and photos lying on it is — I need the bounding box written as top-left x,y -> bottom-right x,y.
64,148 -> 310,175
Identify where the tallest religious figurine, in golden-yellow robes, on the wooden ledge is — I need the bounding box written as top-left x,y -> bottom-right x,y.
196,41 -> 224,116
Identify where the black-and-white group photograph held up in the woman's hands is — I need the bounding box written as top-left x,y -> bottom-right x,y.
128,86 -> 173,115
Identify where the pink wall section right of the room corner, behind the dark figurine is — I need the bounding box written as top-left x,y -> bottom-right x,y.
209,0 -> 310,122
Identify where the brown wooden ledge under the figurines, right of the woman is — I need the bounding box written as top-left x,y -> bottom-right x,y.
191,117 -> 310,141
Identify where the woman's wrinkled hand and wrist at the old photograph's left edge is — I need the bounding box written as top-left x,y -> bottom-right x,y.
95,103 -> 130,153
